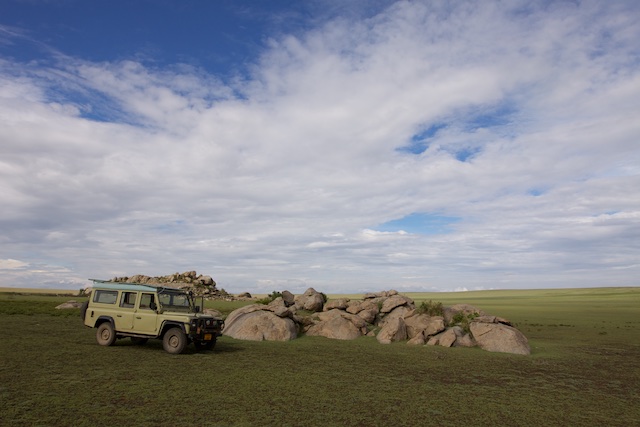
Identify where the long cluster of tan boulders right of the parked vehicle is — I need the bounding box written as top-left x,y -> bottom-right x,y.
223,288 -> 531,355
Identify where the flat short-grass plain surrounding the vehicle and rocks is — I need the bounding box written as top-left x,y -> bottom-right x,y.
0,288 -> 640,426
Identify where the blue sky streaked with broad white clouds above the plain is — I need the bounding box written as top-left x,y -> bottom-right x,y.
0,0 -> 640,293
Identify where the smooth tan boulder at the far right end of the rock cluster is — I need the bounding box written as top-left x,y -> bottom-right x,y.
469,322 -> 531,355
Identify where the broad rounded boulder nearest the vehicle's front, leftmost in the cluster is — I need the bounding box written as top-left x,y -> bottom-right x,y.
223,304 -> 298,341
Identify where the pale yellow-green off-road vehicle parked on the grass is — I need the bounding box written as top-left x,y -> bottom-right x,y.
81,279 -> 224,354
